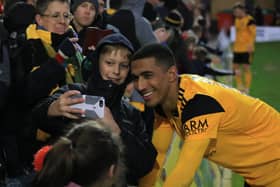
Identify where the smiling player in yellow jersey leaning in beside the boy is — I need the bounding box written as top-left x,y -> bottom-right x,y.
131,44 -> 280,187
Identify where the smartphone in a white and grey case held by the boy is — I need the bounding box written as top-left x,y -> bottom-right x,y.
71,95 -> 105,119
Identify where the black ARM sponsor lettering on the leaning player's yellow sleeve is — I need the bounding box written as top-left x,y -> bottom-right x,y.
183,119 -> 208,136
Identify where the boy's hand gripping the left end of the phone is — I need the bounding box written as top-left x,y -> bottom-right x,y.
48,90 -> 85,119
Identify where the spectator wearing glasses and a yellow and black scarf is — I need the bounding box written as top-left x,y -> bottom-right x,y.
25,0 -> 83,105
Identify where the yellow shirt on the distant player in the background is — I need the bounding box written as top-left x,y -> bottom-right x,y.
233,15 -> 256,53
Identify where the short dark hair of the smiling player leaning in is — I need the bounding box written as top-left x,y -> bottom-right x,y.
131,43 -> 176,69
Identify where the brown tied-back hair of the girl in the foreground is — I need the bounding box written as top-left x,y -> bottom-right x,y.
33,121 -> 122,187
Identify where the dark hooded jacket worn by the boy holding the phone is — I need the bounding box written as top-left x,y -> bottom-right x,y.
32,33 -> 157,185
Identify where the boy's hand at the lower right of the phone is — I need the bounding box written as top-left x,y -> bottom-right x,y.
99,107 -> 121,134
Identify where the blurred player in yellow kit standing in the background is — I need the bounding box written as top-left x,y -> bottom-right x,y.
233,3 -> 256,93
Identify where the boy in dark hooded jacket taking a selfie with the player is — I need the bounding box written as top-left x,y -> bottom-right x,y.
32,33 -> 156,185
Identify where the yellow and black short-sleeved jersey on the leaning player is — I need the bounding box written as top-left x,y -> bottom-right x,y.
158,75 -> 280,186
